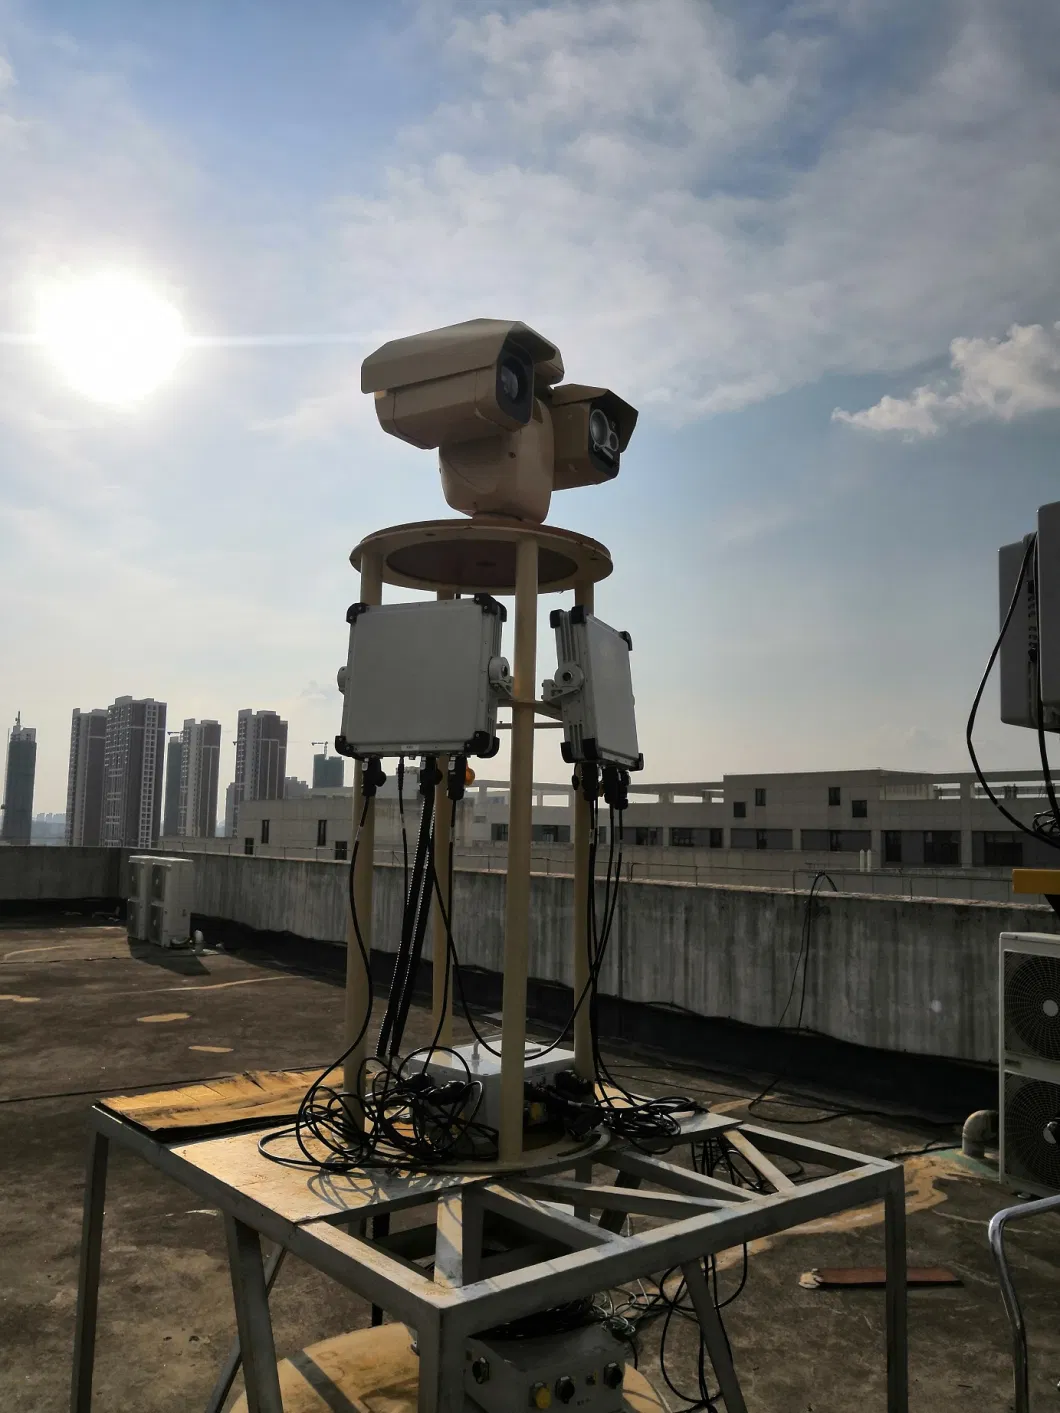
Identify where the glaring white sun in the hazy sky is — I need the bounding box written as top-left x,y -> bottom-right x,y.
37,273 -> 188,406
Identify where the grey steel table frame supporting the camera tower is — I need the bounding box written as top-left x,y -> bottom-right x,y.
71,1106 -> 909,1413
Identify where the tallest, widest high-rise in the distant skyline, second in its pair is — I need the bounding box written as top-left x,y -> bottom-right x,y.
100,697 -> 165,849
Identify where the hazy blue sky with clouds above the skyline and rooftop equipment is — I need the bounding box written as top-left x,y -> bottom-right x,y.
0,0 -> 1060,811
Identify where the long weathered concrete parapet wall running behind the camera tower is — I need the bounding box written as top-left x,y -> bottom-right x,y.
182,853 -> 1057,1061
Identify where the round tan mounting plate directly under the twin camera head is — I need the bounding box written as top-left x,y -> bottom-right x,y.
349,516 -> 612,593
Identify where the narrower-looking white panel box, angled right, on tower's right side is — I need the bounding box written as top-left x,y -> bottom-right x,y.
551,605 -> 644,770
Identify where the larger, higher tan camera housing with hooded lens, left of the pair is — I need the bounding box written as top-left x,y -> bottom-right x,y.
360,319 -> 563,449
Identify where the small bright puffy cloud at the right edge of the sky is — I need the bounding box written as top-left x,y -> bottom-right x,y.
832,322 -> 1060,437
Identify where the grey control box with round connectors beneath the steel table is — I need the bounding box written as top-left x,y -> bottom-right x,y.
464,1324 -> 626,1413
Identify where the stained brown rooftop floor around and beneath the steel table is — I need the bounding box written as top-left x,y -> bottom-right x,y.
0,918 -> 1060,1413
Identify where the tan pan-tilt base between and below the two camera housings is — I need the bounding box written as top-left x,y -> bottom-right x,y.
438,401 -> 554,524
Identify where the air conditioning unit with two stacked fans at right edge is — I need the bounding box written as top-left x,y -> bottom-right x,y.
998,933 -> 1060,1195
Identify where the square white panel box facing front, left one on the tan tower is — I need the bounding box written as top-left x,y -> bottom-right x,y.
335,593 -> 512,759
